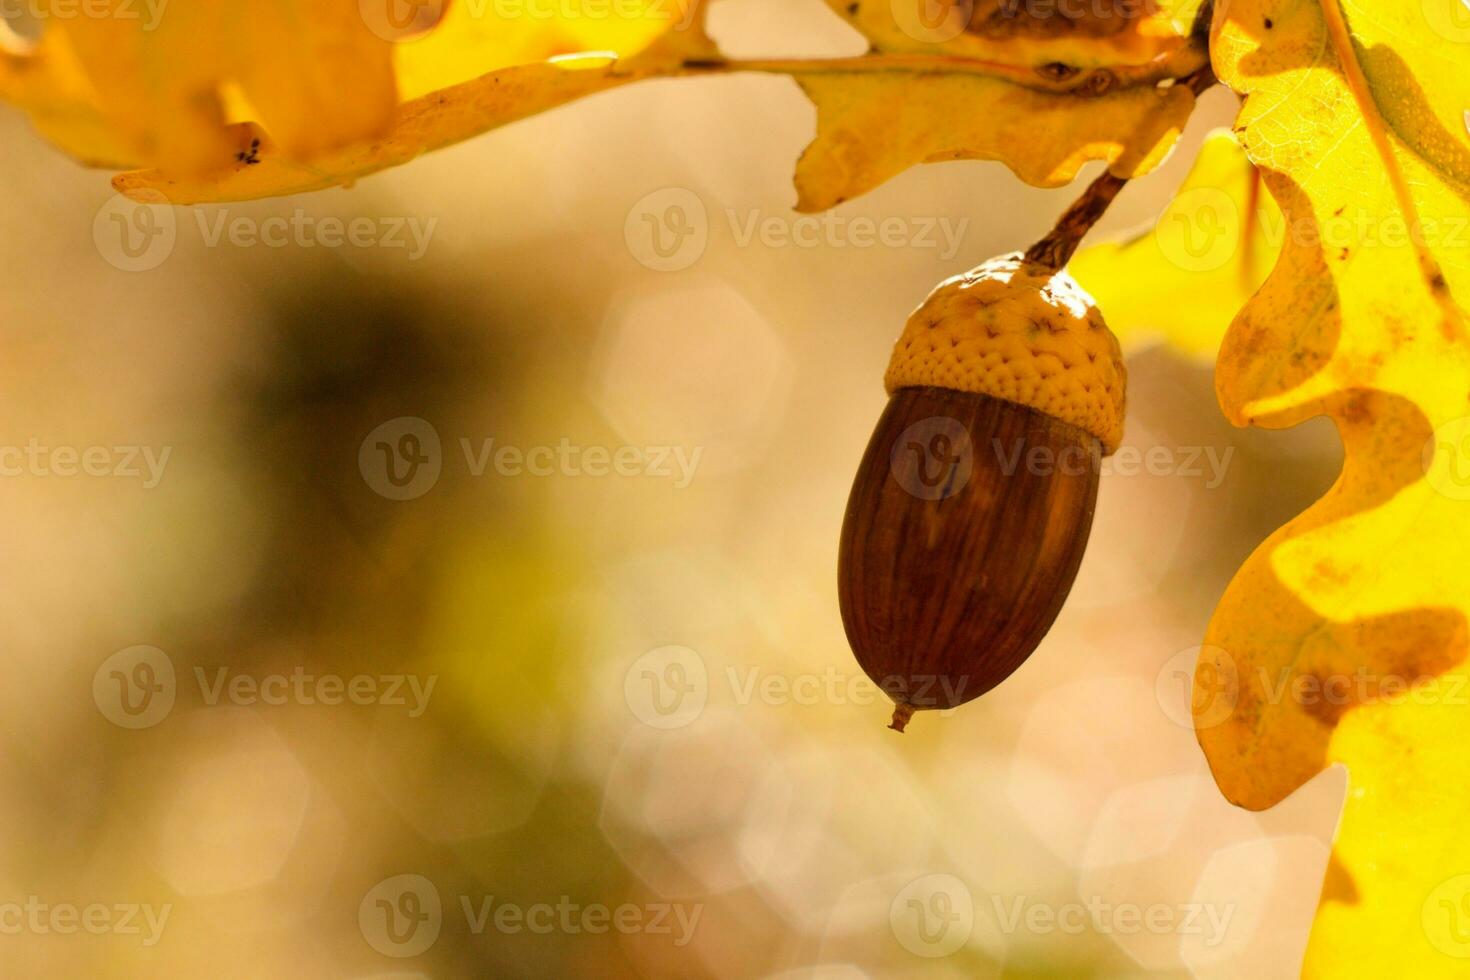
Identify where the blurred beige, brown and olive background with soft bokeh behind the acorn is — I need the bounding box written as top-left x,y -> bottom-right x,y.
0,0 -> 1344,980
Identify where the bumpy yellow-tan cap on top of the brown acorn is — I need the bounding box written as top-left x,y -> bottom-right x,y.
883,253 -> 1127,455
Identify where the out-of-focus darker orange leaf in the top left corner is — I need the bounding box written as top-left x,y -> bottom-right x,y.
0,0 -> 397,172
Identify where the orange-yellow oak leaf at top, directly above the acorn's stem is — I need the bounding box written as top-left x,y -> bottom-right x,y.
794,0 -> 1207,212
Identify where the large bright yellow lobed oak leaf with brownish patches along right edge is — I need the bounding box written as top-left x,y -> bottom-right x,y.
1195,0 -> 1470,977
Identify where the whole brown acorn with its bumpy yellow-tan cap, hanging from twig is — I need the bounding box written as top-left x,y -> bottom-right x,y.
838,253 -> 1126,732
